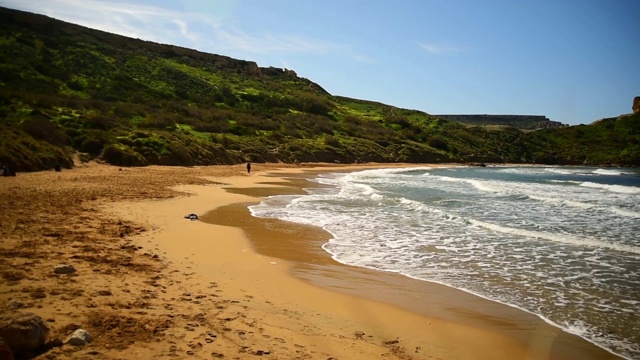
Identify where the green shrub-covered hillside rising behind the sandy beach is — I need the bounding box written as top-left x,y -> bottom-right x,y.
0,8 -> 640,171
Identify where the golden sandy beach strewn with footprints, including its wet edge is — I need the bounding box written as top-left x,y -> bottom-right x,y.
0,163 -> 617,359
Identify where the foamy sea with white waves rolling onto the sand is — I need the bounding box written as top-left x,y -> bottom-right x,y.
250,166 -> 640,359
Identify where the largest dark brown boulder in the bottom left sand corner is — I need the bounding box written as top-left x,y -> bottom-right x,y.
0,312 -> 50,354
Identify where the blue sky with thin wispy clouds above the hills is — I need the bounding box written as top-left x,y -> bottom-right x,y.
0,0 -> 640,124
